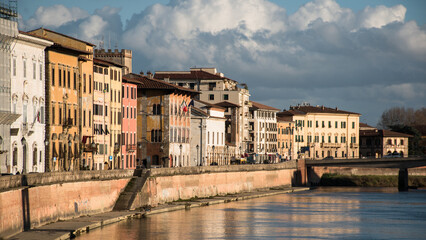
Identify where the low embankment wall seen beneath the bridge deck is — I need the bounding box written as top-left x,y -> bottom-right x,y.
307,167 -> 426,185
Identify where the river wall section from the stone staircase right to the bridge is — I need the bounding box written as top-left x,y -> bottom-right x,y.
131,161 -> 297,209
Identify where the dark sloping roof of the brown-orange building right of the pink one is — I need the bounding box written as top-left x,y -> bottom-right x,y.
122,73 -> 199,94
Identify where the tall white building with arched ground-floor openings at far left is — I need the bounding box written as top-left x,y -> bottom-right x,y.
7,32 -> 53,174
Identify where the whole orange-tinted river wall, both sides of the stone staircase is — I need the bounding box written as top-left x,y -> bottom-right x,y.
0,161 -> 297,238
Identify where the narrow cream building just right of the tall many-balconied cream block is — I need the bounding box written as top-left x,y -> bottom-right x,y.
248,101 -> 279,163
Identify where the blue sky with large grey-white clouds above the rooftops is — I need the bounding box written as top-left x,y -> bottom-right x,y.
18,0 -> 426,126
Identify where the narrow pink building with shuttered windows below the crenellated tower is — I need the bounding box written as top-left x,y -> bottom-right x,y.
121,79 -> 138,169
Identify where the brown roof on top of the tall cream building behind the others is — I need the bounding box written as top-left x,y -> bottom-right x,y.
154,70 -> 236,82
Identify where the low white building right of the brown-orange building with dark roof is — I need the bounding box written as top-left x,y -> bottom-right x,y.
190,100 -> 228,166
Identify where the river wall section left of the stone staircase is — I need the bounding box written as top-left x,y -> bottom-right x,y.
0,170 -> 133,238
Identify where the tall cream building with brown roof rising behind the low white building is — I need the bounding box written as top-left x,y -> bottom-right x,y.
155,68 -> 250,157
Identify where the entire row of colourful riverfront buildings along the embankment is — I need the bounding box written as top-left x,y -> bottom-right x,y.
0,18 -> 408,174
